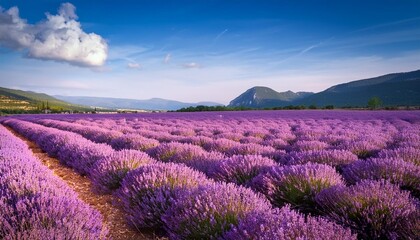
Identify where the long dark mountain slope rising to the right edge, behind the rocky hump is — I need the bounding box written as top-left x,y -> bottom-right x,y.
294,70 -> 420,107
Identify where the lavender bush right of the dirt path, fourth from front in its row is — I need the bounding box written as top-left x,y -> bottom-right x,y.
89,150 -> 155,193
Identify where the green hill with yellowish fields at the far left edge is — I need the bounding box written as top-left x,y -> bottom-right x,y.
0,87 -> 91,111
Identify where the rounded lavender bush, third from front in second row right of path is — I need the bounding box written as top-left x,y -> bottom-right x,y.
209,155 -> 276,185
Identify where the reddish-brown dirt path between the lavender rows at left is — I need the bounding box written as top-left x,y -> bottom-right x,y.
5,126 -> 158,240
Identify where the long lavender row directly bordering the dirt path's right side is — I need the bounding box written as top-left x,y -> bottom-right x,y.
4,120 -> 355,239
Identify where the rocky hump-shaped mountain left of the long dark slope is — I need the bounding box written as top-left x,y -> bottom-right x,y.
229,87 -> 313,108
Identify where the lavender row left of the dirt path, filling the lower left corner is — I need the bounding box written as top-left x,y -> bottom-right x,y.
0,125 -> 107,239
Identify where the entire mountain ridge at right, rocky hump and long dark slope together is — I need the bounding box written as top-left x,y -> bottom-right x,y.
229,70 -> 420,108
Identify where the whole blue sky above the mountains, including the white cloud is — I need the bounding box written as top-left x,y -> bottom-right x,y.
0,0 -> 420,104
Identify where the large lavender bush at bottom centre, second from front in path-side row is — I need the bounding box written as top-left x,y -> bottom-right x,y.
162,183 -> 271,239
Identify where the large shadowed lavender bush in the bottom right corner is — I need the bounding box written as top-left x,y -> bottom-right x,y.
316,180 -> 420,239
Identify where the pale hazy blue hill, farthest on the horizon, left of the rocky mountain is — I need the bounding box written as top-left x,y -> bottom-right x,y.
55,95 -> 222,110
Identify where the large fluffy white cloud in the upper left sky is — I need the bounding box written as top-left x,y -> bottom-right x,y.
0,3 -> 108,67
